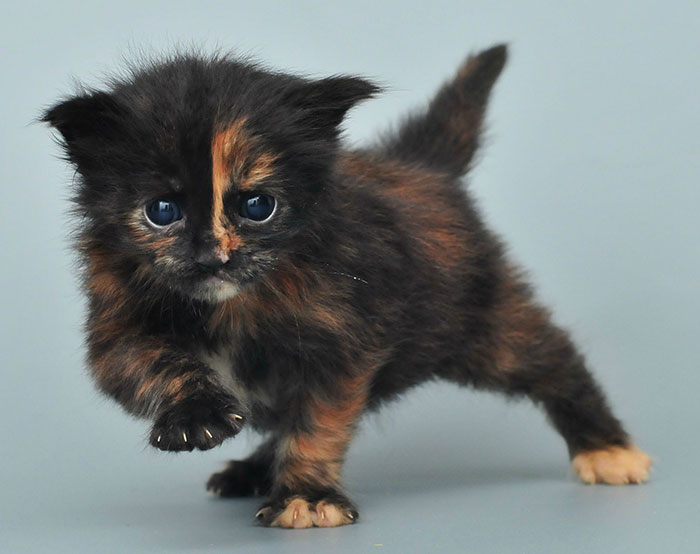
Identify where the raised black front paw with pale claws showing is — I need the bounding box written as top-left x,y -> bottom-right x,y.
149,394 -> 245,452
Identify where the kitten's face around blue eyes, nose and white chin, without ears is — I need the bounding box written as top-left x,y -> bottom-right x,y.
115,112 -> 302,302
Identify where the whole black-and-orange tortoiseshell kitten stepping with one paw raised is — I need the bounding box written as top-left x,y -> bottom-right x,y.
44,46 -> 650,527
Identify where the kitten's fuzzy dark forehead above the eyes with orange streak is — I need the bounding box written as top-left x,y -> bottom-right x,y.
115,58 -> 286,201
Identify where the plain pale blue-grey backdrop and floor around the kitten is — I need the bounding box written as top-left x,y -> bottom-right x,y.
0,0 -> 700,553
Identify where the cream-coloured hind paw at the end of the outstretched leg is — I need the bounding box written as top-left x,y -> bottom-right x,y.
571,445 -> 651,485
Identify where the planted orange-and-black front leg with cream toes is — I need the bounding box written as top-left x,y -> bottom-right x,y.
256,372 -> 371,528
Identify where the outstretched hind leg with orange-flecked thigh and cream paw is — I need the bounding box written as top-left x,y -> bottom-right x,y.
445,272 -> 651,485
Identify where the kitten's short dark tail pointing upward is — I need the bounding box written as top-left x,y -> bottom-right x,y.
383,44 -> 507,177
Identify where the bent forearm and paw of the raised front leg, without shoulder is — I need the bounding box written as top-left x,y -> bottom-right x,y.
88,314 -> 246,451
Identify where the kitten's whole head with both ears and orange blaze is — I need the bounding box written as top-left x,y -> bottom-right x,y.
43,56 -> 378,302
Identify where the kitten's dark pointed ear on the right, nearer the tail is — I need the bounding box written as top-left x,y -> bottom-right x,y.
287,75 -> 381,136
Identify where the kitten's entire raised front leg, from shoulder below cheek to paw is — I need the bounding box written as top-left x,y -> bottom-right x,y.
86,247 -> 246,451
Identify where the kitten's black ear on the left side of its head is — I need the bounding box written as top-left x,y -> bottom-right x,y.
41,92 -> 121,150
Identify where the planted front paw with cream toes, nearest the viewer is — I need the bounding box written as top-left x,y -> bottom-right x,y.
255,493 -> 358,529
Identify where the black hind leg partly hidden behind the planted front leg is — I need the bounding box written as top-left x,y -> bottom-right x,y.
207,437 -> 277,498
